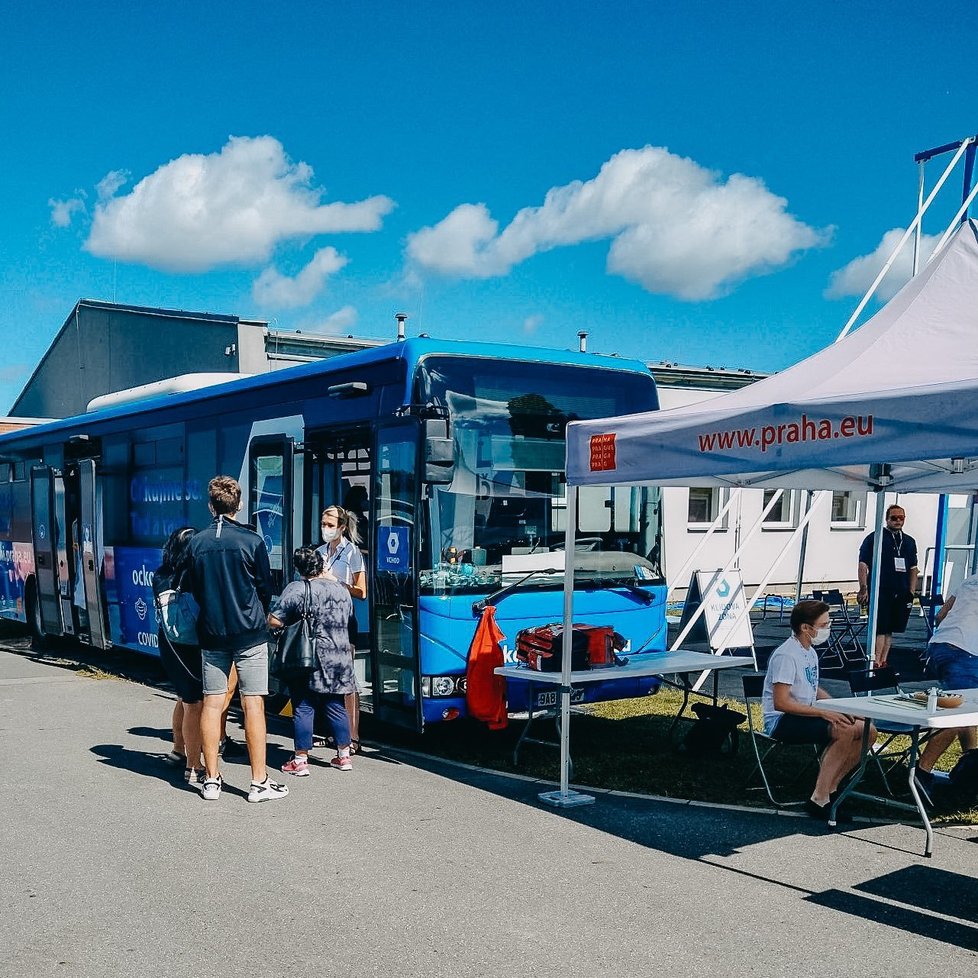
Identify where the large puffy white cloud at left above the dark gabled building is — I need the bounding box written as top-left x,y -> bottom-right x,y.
85,136 -> 394,272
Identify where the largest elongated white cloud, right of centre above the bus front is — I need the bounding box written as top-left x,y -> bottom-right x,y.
407,146 -> 831,300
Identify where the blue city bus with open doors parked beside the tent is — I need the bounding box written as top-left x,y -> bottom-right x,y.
0,339 -> 666,729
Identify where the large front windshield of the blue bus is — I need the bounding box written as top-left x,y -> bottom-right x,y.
415,357 -> 662,592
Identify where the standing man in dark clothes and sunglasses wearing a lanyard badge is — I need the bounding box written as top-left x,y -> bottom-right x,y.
856,505 -> 918,669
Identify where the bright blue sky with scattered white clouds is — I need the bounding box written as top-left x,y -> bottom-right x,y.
0,0 -> 978,412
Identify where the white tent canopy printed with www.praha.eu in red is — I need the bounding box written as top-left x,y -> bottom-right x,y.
567,221 -> 978,492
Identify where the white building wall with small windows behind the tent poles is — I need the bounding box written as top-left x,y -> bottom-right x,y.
659,383 -> 948,598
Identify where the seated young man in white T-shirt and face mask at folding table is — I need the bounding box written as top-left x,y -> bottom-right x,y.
761,601 -> 875,821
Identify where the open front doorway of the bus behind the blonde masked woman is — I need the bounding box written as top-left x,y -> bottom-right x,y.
302,426 -> 374,713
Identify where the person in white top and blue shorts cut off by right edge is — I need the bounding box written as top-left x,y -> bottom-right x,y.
917,574 -> 978,791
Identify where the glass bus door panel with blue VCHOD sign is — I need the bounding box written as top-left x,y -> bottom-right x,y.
368,418 -> 423,730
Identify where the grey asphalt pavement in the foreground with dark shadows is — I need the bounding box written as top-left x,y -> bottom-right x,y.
0,643 -> 978,978
